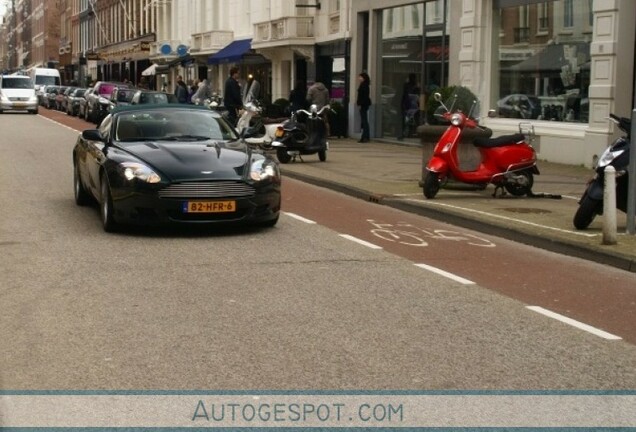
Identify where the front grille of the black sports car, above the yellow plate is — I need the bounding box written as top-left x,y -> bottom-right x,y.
159,181 -> 255,199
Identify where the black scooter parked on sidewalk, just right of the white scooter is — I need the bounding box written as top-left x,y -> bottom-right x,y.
271,105 -> 331,163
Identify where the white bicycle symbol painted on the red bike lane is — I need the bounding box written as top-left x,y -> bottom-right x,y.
367,219 -> 496,247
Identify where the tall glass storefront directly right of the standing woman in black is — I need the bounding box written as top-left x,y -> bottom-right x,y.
376,0 -> 449,138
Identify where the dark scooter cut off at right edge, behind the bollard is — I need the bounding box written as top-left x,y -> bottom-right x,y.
573,114 -> 632,230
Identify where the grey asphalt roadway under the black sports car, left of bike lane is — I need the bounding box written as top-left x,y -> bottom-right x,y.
0,109 -> 636,390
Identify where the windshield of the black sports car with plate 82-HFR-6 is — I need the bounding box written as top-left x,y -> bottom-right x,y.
115,110 -> 238,142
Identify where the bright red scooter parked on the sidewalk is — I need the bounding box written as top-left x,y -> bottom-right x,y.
422,93 -> 539,199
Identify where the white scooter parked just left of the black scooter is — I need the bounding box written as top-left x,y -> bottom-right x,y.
236,80 -> 287,149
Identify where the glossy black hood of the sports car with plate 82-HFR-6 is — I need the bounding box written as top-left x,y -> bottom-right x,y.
120,140 -> 251,181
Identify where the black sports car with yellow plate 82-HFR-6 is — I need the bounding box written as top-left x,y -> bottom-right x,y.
73,104 -> 281,231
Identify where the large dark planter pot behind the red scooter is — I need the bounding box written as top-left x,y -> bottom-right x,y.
417,124 -> 492,186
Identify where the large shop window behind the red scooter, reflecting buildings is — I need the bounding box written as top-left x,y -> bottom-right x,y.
493,0 -> 593,123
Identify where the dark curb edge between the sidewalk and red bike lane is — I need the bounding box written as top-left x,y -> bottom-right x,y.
281,167 -> 636,273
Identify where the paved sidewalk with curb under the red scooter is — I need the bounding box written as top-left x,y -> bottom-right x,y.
281,138 -> 636,272
